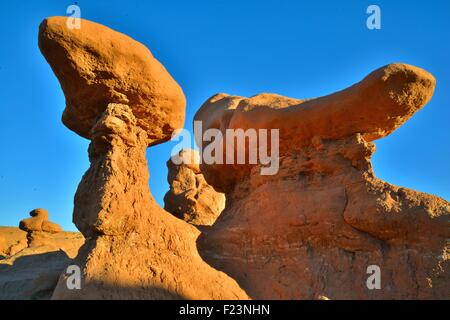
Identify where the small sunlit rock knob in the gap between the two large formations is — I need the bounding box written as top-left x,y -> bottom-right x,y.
164,149 -> 225,226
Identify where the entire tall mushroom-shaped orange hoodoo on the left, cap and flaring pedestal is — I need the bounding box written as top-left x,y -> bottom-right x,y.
39,17 -> 248,299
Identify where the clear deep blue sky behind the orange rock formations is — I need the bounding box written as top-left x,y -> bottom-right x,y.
0,0 -> 450,230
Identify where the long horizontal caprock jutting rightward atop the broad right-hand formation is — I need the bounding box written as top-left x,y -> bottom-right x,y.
194,63 -> 436,192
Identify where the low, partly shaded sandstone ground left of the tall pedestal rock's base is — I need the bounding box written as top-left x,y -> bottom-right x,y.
0,227 -> 84,300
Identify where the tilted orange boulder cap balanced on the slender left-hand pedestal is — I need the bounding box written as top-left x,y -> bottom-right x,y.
39,17 -> 186,145
